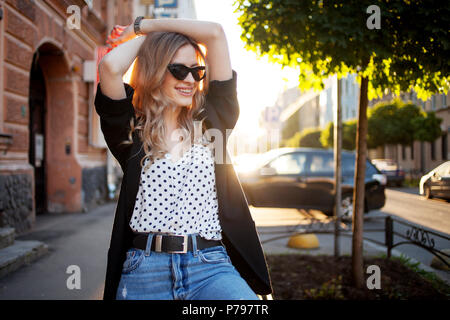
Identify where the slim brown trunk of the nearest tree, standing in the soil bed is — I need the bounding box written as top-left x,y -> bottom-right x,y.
352,77 -> 369,288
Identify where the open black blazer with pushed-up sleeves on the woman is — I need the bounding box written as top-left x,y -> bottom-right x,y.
94,70 -> 272,300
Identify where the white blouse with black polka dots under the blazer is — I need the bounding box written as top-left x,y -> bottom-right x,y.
130,143 -> 222,240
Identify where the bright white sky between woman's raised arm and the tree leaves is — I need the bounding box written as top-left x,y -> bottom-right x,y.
195,0 -> 298,138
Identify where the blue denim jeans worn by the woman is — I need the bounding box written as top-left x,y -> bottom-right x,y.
116,234 -> 259,300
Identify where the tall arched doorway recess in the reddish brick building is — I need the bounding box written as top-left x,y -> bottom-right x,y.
29,41 -> 82,214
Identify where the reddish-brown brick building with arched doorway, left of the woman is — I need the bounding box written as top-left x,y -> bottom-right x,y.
0,0 -> 136,234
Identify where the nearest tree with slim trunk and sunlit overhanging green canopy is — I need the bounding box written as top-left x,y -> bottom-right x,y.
236,0 -> 450,288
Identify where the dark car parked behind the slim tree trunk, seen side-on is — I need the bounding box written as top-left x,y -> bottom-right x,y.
236,148 -> 386,217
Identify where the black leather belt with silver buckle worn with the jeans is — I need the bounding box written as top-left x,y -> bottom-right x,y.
133,234 -> 223,253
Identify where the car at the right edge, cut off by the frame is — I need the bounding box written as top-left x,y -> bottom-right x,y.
419,161 -> 450,199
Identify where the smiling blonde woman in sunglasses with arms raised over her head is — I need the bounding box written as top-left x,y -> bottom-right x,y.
95,17 -> 272,300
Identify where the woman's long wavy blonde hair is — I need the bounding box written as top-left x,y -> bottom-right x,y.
121,32 -> 209,170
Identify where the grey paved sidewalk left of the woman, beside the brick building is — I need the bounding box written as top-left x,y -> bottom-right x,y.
0,202 -> 116,300
